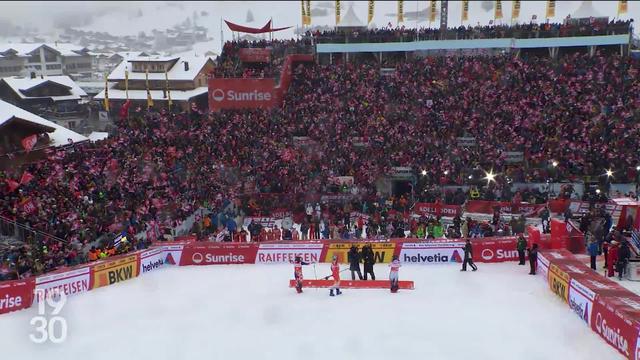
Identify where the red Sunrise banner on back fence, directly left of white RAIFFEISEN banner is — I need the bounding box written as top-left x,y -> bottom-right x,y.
180,243 -> 258,266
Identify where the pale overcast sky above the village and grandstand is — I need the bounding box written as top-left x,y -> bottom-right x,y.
0,1 -> 640,53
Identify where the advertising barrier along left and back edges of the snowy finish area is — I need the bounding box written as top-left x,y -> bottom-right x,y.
0,237 -> 518,314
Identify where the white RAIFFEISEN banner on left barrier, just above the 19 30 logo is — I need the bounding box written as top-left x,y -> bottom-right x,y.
33,266 -> 91,302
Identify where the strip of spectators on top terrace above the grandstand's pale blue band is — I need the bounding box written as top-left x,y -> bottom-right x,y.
306,18 -> 633,43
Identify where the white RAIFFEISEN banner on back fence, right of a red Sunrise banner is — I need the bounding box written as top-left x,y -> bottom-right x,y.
256,243 -> 324,264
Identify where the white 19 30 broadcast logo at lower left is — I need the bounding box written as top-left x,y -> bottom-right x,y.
29,289 -> 68,344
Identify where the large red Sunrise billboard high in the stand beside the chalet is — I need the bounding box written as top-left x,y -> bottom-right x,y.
209,79 -> 279,110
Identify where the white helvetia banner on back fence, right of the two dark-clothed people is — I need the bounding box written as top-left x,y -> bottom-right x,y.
400,242 -> 464,265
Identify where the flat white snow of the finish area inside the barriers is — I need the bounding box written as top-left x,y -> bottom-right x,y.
0,263 -> 623,360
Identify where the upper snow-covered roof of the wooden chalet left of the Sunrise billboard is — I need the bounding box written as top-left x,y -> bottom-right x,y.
109,56 -> 213,81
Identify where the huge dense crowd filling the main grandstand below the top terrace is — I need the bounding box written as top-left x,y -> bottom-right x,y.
0,30 -> 640,276
